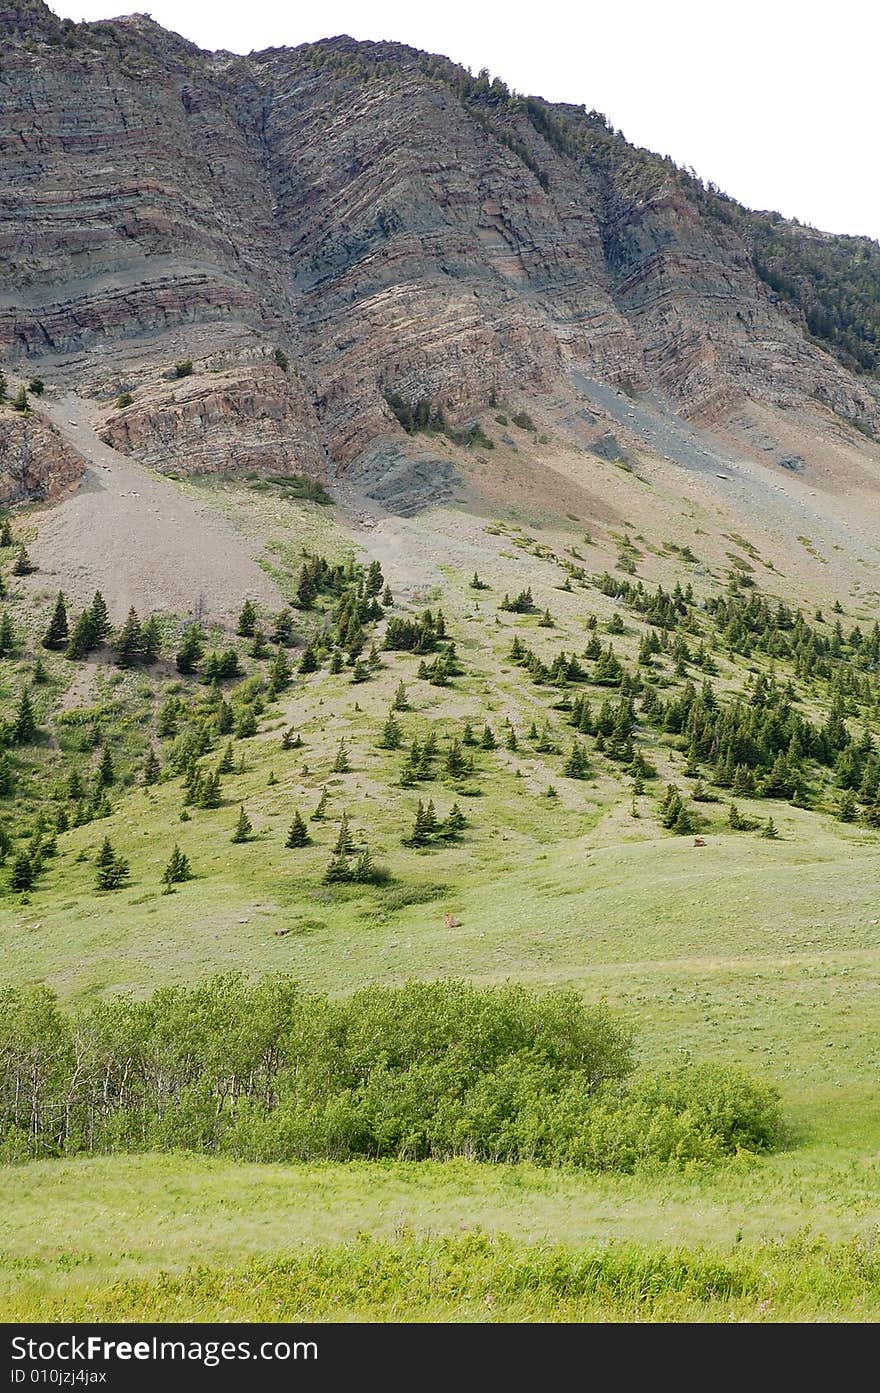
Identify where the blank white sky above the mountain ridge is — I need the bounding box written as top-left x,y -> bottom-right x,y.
52,0 -> 880,240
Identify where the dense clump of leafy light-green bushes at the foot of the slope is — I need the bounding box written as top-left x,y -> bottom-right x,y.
0,975 -> 783,1172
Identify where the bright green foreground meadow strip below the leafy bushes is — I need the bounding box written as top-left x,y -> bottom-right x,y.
0,1148 -> 880,1321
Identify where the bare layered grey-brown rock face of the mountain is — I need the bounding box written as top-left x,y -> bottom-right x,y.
0,0 -> 880,501
